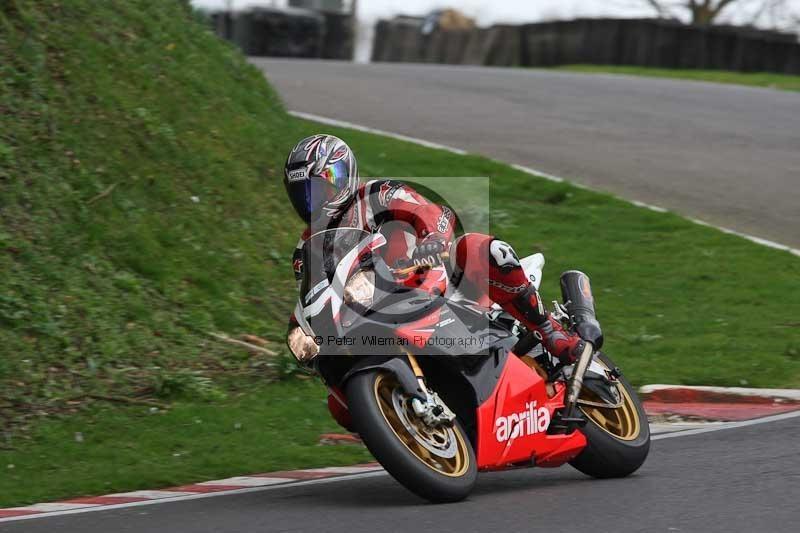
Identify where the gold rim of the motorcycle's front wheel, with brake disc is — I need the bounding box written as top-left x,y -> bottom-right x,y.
374,374 -> 470,477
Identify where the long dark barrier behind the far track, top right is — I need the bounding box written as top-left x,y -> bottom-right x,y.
372,17 -> 800,74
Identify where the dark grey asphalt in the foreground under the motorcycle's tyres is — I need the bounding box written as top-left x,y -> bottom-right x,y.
7,417 -> 800,533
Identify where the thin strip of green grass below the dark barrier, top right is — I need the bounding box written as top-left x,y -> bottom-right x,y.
557,65 -> 800,91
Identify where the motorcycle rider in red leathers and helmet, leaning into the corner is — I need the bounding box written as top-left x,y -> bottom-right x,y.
283,135 -> 584,363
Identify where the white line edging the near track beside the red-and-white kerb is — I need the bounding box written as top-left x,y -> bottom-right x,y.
0,411 -> 800,523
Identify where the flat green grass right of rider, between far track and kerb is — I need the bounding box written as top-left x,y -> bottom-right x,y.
300,119 -> 800,387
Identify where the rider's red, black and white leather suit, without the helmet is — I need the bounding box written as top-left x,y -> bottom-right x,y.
293,180 -> 583,362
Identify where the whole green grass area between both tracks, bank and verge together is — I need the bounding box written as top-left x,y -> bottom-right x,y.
0,0 -> 800,505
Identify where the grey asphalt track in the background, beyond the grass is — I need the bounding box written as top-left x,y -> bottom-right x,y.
253,59 -> 800,248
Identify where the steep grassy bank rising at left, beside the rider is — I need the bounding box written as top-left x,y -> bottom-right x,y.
0,0 -> 302,422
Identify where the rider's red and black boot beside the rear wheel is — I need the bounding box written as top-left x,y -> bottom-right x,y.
503,285 -> 585,364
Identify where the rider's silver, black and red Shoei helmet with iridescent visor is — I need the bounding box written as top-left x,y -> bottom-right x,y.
283,135 -> 358,223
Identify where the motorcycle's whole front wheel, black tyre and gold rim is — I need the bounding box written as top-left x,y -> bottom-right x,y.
345,370 -> 478,503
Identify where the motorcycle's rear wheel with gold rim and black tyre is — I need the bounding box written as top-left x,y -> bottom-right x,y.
570,353 -> 650,478
